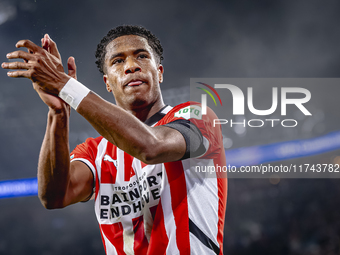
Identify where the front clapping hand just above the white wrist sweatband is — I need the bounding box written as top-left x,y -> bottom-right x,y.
2,36 -> 70,96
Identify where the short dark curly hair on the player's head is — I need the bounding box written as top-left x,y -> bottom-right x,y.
96,25 -> 163,74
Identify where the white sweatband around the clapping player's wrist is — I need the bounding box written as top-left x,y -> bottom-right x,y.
59,78 -> 90,110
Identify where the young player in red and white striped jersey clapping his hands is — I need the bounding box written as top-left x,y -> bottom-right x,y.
2,26 -> 227,254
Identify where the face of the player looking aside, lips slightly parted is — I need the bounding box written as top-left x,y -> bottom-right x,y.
104,35 -> 163,110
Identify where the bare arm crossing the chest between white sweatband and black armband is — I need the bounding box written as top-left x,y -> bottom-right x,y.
77,93 -> 186,164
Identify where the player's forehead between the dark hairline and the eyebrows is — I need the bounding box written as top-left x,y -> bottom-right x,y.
105,35 -> 152,58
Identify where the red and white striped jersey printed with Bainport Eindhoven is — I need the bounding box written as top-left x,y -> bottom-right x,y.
71,102 -> 227,255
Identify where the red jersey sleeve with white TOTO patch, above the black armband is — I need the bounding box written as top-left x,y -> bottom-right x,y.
157,102 -> 223,158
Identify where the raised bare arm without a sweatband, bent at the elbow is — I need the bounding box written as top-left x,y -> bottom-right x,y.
38,105 -> 93,209
